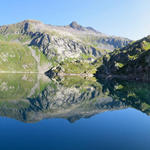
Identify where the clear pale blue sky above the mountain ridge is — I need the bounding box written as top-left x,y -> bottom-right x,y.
0,0 -> 150,40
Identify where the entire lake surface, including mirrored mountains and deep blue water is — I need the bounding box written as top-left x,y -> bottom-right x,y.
0,74 -> 150,150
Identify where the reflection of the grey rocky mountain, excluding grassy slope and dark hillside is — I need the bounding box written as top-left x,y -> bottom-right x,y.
0,77 -> 126,122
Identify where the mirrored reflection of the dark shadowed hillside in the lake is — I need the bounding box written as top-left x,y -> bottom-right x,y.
98,79 -> 150,115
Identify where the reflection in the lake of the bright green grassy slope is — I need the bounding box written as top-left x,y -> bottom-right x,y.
0,74 -> 47,100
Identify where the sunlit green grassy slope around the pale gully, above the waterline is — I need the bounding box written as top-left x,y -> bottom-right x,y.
0,31 -> 51,72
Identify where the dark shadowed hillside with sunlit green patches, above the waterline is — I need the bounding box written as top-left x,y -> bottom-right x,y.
96,36 -> 150,80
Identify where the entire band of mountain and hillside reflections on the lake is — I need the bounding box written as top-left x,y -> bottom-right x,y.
0,74 -> 150,122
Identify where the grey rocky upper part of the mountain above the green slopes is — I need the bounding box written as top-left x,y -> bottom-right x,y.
0,20 -> 131,62
